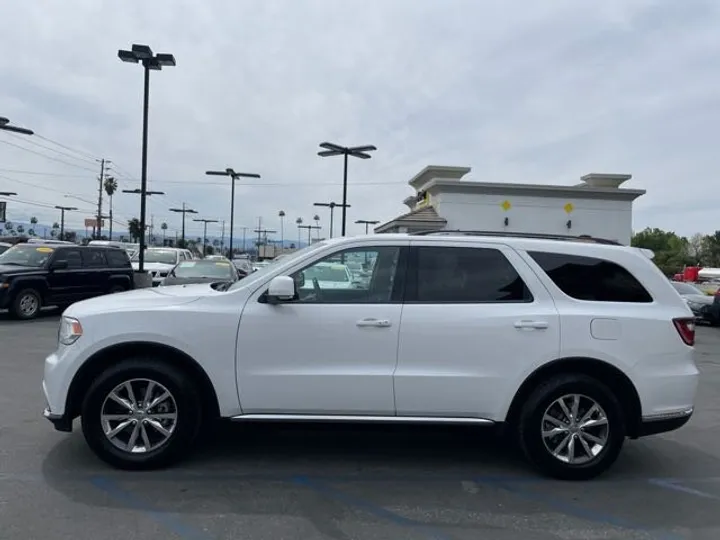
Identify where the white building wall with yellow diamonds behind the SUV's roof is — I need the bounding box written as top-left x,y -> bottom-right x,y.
432,192 -> 632,245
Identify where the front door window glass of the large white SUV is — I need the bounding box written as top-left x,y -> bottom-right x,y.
292,246 -> 401,304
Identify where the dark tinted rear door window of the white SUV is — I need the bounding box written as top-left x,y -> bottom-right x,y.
410,247 -> 532,303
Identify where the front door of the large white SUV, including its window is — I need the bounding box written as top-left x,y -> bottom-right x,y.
237,242 -> 406,415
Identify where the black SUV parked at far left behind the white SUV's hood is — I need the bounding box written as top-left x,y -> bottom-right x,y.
0,244 -> 133,319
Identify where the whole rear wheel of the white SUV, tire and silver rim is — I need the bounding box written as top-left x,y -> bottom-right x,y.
518,374 -> 626,480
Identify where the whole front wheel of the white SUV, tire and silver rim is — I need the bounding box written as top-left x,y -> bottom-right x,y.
81,357 -> 203,470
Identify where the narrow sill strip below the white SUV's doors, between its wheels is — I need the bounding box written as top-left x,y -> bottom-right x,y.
230,414 -> 495,426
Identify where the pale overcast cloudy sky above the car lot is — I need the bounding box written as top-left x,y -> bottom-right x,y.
0,0 -> 720,239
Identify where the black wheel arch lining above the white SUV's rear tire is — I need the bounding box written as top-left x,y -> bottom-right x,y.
506,357 -> 642,438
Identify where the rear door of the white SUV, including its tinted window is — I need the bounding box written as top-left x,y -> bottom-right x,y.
394,239 -> 560,420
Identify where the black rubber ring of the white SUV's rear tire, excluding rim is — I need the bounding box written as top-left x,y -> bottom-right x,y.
519,375 -> 626,480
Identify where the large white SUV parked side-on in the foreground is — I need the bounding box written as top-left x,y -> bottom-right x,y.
43,234 -> 698,479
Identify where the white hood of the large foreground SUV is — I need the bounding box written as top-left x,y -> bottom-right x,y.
64,284 -> 217,317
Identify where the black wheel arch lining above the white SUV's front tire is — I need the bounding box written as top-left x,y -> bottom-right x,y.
65,341 -> 220,420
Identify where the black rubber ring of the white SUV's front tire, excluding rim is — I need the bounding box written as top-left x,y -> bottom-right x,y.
81,359 -> 202,470
